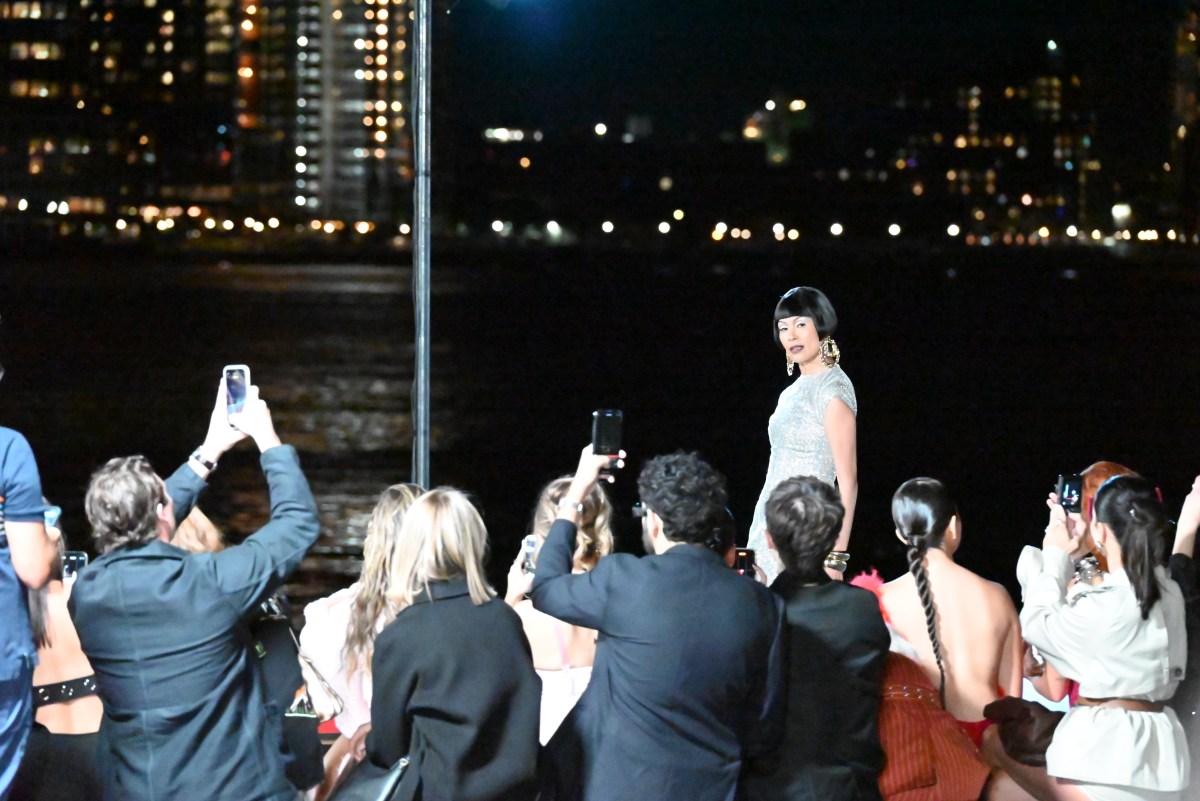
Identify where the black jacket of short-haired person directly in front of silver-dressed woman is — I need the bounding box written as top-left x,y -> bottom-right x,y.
743,572 -> 890,801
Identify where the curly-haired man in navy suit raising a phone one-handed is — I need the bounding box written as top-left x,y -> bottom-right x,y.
532,446 -> 784,801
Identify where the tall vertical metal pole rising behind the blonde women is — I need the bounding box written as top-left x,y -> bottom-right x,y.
413,0 -> 433,487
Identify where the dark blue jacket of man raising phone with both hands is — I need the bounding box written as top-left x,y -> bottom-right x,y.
70,445 -> 319,801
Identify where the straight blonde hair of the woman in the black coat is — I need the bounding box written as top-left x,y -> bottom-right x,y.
389,487 -> 496,613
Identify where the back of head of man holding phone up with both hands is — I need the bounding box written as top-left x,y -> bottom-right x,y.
84,456 -> 167,554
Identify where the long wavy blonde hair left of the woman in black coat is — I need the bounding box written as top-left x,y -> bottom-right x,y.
343,483 -> 425,673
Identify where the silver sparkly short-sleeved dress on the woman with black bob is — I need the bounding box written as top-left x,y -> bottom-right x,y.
746,366 -> 858,584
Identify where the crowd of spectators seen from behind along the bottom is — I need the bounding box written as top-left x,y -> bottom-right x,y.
0,378 -> 1200,801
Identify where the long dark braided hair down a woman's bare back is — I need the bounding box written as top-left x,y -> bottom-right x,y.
892,478 -> 959,707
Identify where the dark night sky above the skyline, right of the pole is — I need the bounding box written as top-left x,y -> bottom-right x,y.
446,0 -> 1180,161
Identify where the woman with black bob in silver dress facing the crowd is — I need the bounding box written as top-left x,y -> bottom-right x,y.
746,287 -> 858,582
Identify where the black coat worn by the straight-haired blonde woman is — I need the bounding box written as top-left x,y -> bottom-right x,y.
367,578 -> 541,801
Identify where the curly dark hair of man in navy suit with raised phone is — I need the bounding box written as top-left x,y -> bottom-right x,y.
637,451 -> 728,548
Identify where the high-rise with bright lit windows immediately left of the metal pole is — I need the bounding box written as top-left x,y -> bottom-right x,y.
293,0 -> 412,222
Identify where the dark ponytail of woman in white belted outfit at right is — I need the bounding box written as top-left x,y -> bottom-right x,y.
1093,476 -> 1166,620
